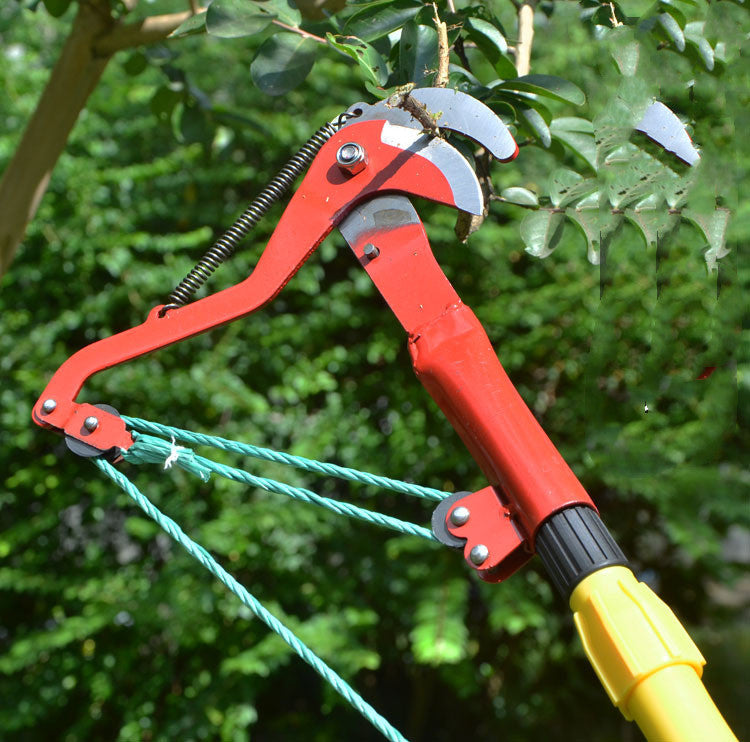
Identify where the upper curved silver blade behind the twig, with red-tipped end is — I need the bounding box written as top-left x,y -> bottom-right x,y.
347,88 -> 518,162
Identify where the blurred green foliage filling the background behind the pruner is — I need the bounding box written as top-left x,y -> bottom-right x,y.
0,3 -> 750,742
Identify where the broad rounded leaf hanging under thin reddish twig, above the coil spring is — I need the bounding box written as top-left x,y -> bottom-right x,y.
250,33 -> 315,95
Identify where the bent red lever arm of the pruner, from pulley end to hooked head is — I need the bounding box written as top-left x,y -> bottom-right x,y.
32,121 -> 472,451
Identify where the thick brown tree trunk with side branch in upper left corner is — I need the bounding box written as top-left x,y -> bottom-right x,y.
0,0 -> 200,277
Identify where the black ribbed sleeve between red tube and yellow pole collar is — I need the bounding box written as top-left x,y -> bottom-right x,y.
535,505 -> 628,600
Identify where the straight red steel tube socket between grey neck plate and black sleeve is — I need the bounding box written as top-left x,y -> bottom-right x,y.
351,215 -> 594,548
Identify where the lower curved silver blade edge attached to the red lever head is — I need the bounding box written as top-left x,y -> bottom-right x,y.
380,121 -> 484,215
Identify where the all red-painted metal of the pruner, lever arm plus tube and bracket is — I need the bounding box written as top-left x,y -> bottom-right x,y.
33,115 -> 593,581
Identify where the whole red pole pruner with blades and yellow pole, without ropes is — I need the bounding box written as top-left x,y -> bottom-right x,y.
32,88 -> 736,742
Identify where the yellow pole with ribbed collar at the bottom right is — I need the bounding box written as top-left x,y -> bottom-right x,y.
570,566 -> 737,742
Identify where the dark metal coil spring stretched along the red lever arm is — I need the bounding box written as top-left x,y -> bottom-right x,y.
161,112 -> 357,316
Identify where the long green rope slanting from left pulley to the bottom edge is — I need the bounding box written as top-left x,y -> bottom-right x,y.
94,459 -> 407,742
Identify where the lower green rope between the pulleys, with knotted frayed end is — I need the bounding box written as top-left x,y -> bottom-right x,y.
122,433 -> 437,541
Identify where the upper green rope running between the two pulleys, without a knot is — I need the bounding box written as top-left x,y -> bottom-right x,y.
122,415 -> 451,500
